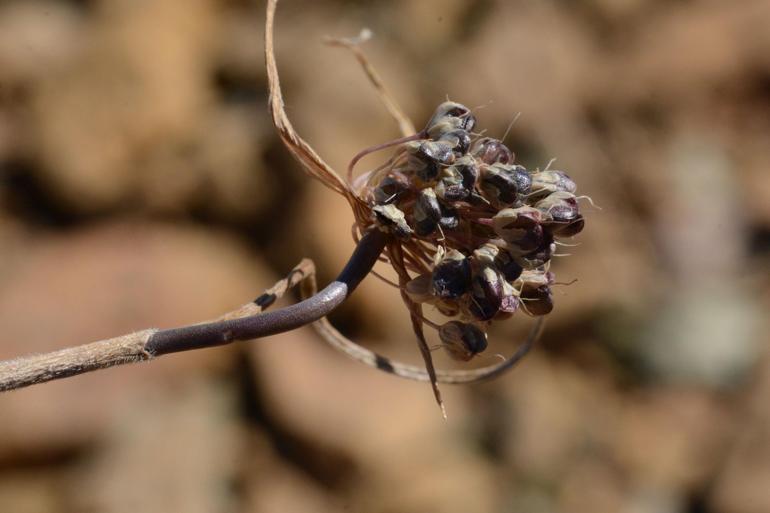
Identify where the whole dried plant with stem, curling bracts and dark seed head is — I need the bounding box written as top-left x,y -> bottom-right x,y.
0,0 -> 584,414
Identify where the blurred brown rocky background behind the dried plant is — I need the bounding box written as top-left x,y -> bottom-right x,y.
0,0 -> 770,513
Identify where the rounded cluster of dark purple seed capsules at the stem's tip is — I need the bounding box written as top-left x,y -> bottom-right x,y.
365,102 -> 584,361
